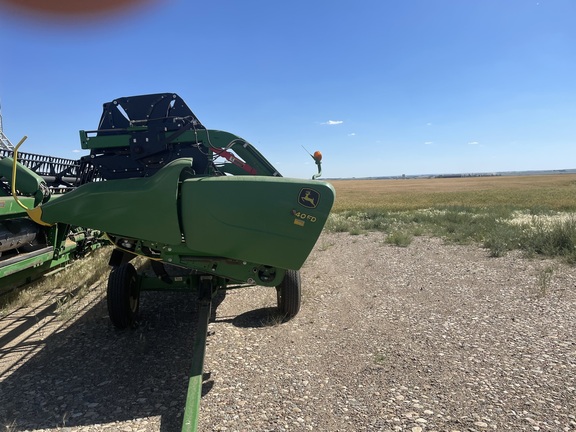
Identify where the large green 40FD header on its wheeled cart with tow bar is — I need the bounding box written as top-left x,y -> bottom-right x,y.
0,93 -> 335,430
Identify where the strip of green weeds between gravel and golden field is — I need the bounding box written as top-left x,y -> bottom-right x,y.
326,206 -> 576,264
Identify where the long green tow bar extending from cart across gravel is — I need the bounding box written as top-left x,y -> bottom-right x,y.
182,276 -> 214,432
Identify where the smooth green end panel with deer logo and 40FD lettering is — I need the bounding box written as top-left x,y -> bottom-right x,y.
182,176 -> 335,270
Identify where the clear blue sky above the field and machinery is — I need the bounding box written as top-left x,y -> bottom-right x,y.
0,0 -> 576,177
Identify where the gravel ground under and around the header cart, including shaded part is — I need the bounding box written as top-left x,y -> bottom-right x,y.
0,233 -> 576,432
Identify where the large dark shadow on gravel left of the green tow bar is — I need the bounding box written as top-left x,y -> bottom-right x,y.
0,286 -> 223,432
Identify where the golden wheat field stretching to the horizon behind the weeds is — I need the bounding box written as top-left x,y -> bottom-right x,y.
330,174 -> 576,212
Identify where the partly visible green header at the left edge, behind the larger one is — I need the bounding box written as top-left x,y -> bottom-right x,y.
0,146 -> 103,296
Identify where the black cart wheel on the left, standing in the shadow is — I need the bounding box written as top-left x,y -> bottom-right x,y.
107,263 -> 140,329
